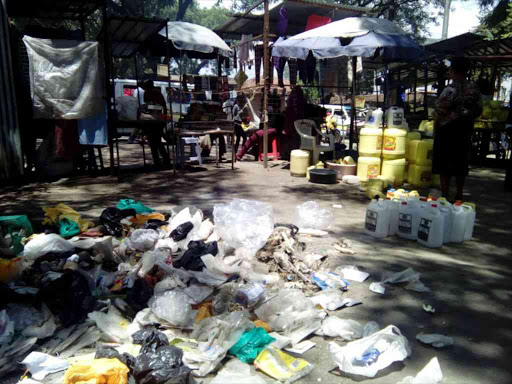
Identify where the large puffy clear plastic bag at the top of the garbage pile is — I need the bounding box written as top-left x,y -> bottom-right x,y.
213,199 -> 274,254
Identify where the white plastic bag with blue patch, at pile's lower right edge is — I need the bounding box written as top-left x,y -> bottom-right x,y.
329,325 -> 411,377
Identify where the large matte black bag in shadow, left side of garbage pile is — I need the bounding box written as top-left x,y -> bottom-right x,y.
39,271 -> 96,327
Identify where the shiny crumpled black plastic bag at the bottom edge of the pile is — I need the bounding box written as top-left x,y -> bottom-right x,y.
132,328 -> 190,384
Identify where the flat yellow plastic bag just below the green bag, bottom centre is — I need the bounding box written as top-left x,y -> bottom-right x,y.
254,347 -> 313,383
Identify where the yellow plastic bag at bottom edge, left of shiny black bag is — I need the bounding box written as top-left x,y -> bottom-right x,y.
64,359 -> 130,384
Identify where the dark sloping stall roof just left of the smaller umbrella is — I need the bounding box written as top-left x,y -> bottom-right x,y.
98,16 -> 167,57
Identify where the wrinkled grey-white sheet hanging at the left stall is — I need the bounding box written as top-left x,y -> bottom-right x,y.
23,36 -> 104,120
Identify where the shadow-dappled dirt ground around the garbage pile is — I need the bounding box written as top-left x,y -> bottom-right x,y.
0,142 -> 512,384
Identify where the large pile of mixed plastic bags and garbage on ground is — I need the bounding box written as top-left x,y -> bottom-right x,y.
0,199 -> 449,384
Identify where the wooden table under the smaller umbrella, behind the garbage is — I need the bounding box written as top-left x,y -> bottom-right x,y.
177,120 -> 235,169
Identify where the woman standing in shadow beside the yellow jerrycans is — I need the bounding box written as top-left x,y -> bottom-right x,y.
432,57 -> 482,200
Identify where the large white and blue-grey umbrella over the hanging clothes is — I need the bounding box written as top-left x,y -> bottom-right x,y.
272,17 -> 424,62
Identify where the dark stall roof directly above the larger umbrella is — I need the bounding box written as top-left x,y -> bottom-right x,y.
214,0 -> 372,39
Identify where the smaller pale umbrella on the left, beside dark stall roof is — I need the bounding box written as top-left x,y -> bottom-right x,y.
159,21 -> 231,56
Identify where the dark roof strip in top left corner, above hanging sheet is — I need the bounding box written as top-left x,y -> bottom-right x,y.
7,0 -> 105,20
